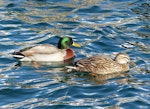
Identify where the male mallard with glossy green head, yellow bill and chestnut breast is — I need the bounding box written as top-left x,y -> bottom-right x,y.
13,37 -> 80,62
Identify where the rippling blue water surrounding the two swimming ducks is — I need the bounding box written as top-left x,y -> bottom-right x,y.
0,0 -> 150,109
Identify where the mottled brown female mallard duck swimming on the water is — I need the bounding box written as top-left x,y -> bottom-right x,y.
67,53 -> 130,74
